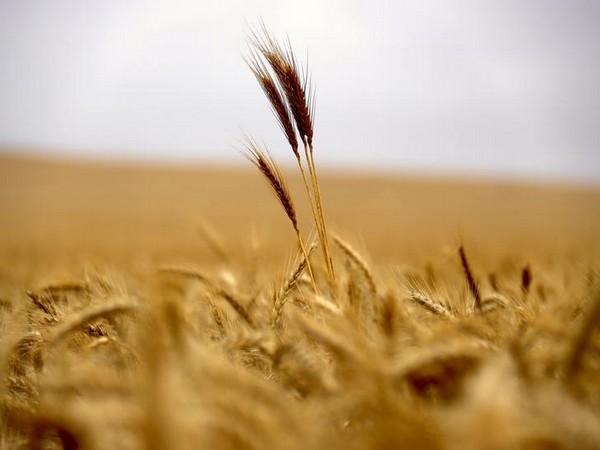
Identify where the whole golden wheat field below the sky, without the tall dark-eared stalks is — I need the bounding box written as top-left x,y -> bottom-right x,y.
0,155 -> 600,449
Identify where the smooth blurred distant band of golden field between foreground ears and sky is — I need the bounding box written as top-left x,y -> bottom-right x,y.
0,156 -> 600,267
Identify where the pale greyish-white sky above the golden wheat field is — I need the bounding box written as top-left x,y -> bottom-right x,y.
0,0 -> 600,184
